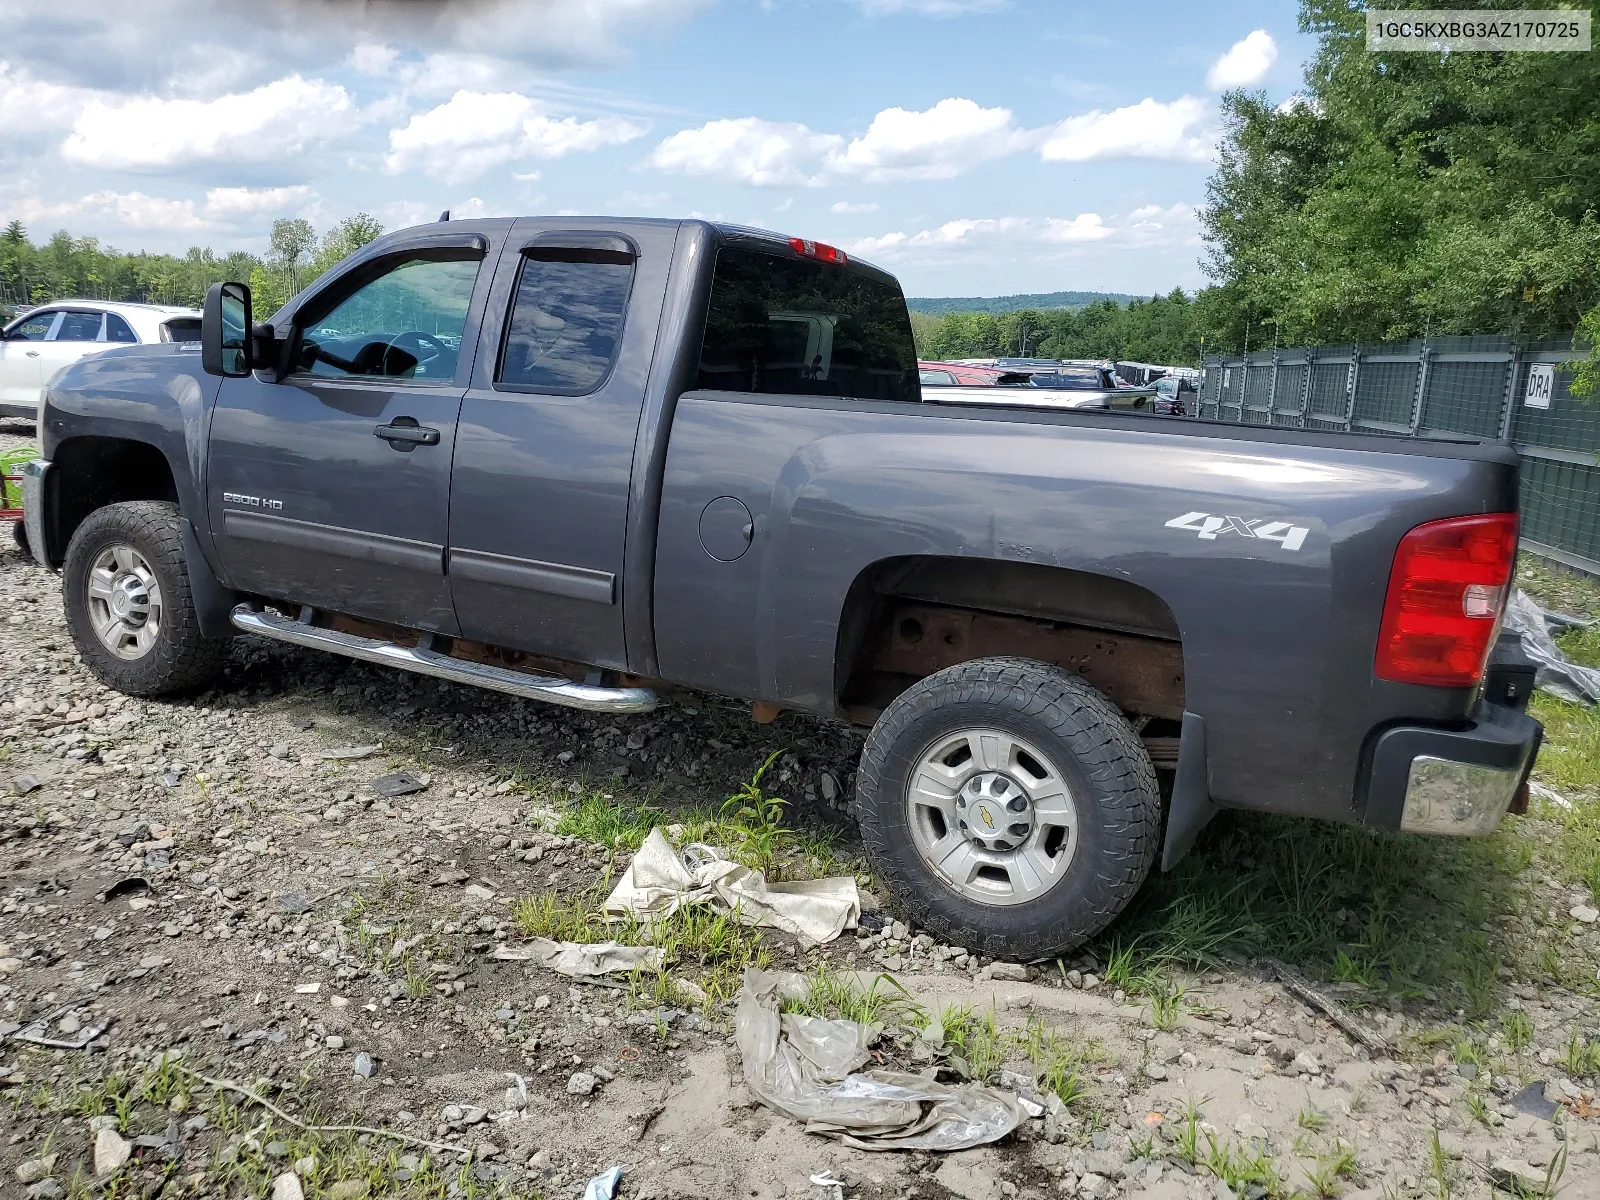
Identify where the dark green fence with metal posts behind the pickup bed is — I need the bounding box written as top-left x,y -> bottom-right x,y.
1200,334 -> 1600,576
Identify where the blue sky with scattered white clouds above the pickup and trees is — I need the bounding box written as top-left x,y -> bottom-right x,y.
0,0 -> 1312,296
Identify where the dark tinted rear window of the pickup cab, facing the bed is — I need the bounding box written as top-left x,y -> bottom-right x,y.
696,246 -> 922,400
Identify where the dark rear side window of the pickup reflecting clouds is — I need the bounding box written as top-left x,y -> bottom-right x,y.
494,246 -> 634,395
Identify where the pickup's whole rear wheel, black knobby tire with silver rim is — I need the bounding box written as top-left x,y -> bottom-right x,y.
856,658 -> 1162,960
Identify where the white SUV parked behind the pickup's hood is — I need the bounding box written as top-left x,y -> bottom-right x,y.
0,301 -> 200,421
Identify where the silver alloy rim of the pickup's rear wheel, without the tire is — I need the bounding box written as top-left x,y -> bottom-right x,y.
906,728 -> 1078,906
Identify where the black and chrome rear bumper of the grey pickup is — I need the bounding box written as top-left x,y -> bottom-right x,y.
1366,699 -> 1544,837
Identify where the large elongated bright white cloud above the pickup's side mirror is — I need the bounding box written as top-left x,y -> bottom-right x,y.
61,75 -> 354,171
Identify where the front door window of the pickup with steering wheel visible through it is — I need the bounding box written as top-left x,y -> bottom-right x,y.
296,254 -> 482,384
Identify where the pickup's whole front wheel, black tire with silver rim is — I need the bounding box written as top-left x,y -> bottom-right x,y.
61,501 -> 227,696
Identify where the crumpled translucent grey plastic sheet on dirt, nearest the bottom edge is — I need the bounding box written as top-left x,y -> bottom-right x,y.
734,966 -> 1027,1150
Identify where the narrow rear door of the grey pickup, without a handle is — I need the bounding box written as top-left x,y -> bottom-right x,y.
450,218 -> 677,669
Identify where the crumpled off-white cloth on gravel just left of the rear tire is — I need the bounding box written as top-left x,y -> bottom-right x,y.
605,827 -> 861,946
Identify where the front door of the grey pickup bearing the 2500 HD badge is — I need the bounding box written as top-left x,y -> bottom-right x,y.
206,246 -> 483,634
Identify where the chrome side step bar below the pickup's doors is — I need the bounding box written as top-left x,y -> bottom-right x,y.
230,605 -> 661,712
